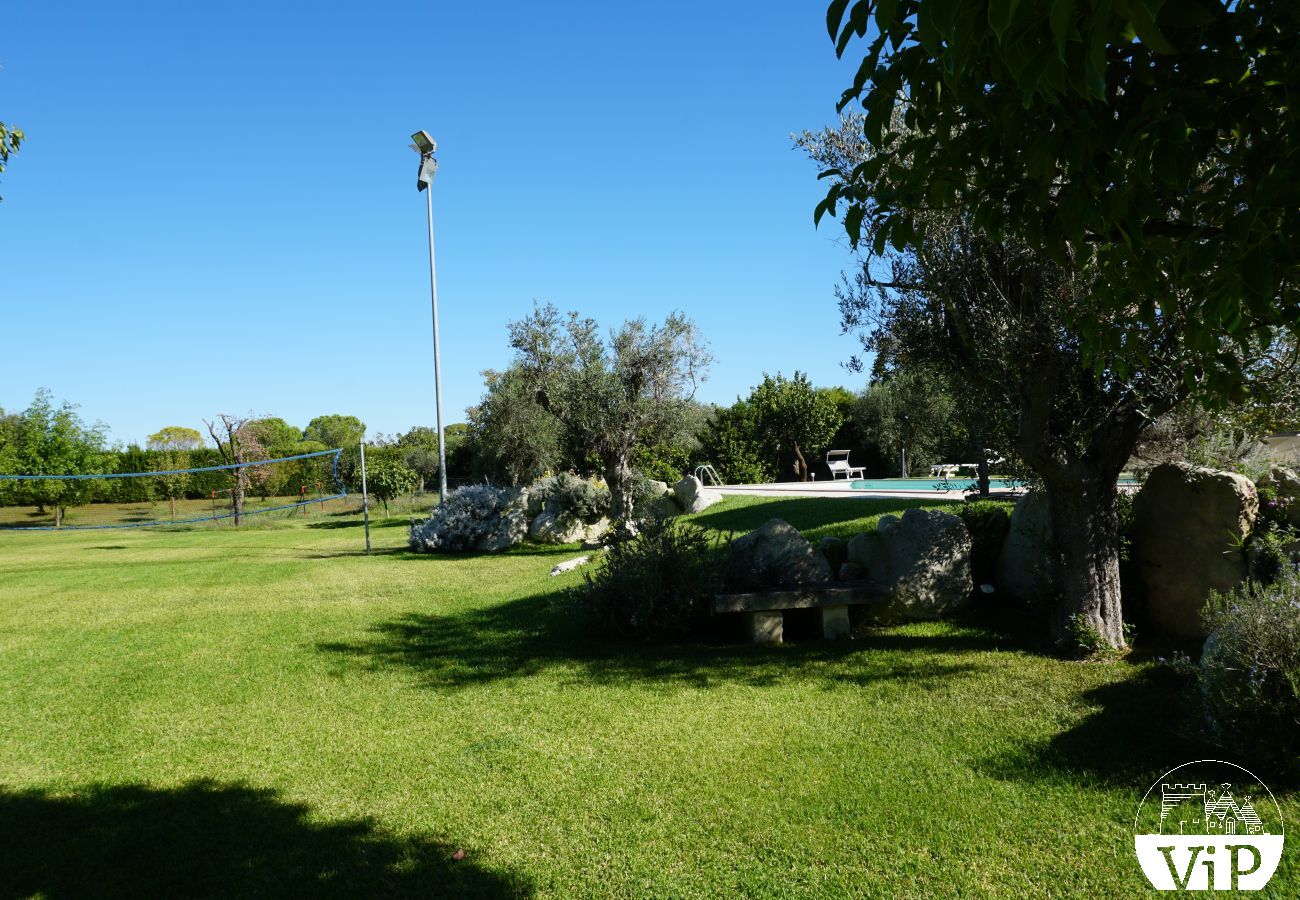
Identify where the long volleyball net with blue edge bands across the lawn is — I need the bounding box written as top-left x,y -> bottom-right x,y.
0,450 -> 347,531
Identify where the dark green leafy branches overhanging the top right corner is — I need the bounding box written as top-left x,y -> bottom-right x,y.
816,0 -> 1300,395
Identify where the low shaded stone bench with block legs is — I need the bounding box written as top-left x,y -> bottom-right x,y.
714,581 -> 885,644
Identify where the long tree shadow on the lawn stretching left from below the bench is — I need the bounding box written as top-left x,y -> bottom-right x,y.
317,593 -> 1005,688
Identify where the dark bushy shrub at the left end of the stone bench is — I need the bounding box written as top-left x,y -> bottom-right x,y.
580,519 -> 723,640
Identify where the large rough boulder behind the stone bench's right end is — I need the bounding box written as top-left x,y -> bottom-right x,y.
850,510 -> 972,622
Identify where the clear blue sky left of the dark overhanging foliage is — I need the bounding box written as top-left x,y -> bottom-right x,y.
0,0 -> 862,441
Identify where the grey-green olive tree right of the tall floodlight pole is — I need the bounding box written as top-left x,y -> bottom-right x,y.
510,304 -> 712,518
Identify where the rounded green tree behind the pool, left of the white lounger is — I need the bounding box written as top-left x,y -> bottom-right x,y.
749,371 -> 844,481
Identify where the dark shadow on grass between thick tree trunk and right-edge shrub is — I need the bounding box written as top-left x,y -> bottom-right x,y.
980,662 -> 1213,787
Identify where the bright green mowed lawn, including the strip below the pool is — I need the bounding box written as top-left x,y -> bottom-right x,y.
0,498 -> 1300,897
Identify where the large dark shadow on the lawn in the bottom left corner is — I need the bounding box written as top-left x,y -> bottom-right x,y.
0,782 -> 532,900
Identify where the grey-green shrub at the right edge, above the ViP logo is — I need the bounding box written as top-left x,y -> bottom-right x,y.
1199,567 -> 1300,775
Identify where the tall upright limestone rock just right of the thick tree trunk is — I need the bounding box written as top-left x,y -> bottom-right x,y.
1134,463 -> 1260,637
